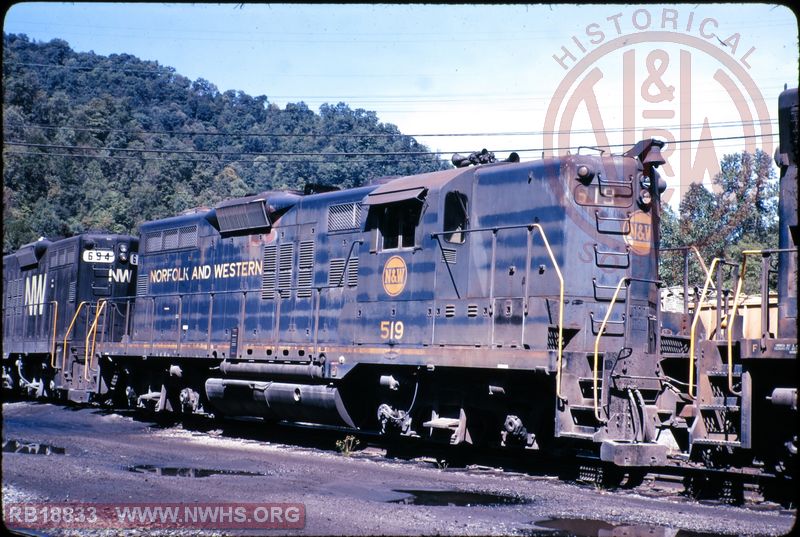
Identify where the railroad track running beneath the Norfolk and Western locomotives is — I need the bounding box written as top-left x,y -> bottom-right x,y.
4,403 -> 797,508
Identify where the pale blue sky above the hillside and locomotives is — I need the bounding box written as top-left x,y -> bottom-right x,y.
3,2 -> 798,201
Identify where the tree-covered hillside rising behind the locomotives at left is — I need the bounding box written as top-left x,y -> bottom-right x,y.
3,34 -> 449,252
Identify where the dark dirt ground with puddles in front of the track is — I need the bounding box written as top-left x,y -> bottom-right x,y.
2,402 -> 796,537
